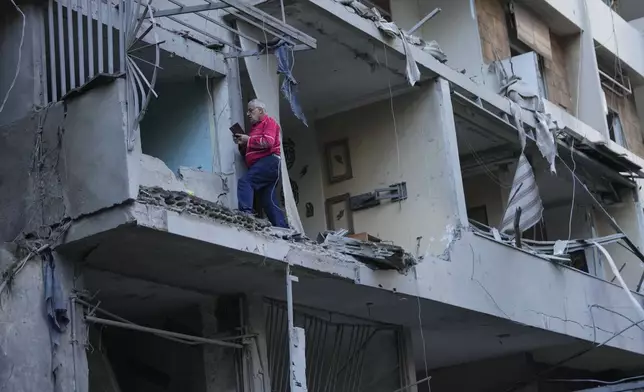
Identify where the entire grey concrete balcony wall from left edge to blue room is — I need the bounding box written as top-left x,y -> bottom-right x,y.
0,76 -> 139,241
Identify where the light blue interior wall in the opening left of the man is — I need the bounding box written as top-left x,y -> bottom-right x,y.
141,79 -> 213,173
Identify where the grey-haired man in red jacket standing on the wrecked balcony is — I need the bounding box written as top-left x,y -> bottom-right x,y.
233,99 -> 288,227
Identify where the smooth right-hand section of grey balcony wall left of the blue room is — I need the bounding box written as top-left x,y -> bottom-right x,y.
61,79 -> 138,218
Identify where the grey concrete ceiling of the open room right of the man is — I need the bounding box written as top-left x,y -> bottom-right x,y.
274,2 -> 410,118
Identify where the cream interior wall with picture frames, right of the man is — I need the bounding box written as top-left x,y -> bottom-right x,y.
316,80 -> 467,253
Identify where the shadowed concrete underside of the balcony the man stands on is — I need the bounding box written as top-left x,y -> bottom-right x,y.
61,227 -> 644,374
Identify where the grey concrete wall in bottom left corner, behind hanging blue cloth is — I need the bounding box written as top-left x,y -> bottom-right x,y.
0,245 -> 88,392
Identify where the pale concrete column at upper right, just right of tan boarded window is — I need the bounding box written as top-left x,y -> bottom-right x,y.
565,0 -> 609,138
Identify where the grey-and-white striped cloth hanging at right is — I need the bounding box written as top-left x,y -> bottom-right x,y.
501,153 -> 543,232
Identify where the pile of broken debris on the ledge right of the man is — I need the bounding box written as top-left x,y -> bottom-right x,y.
318,230 -> 417,271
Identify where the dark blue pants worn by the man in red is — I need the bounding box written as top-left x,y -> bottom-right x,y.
237,155 -> 288,227
